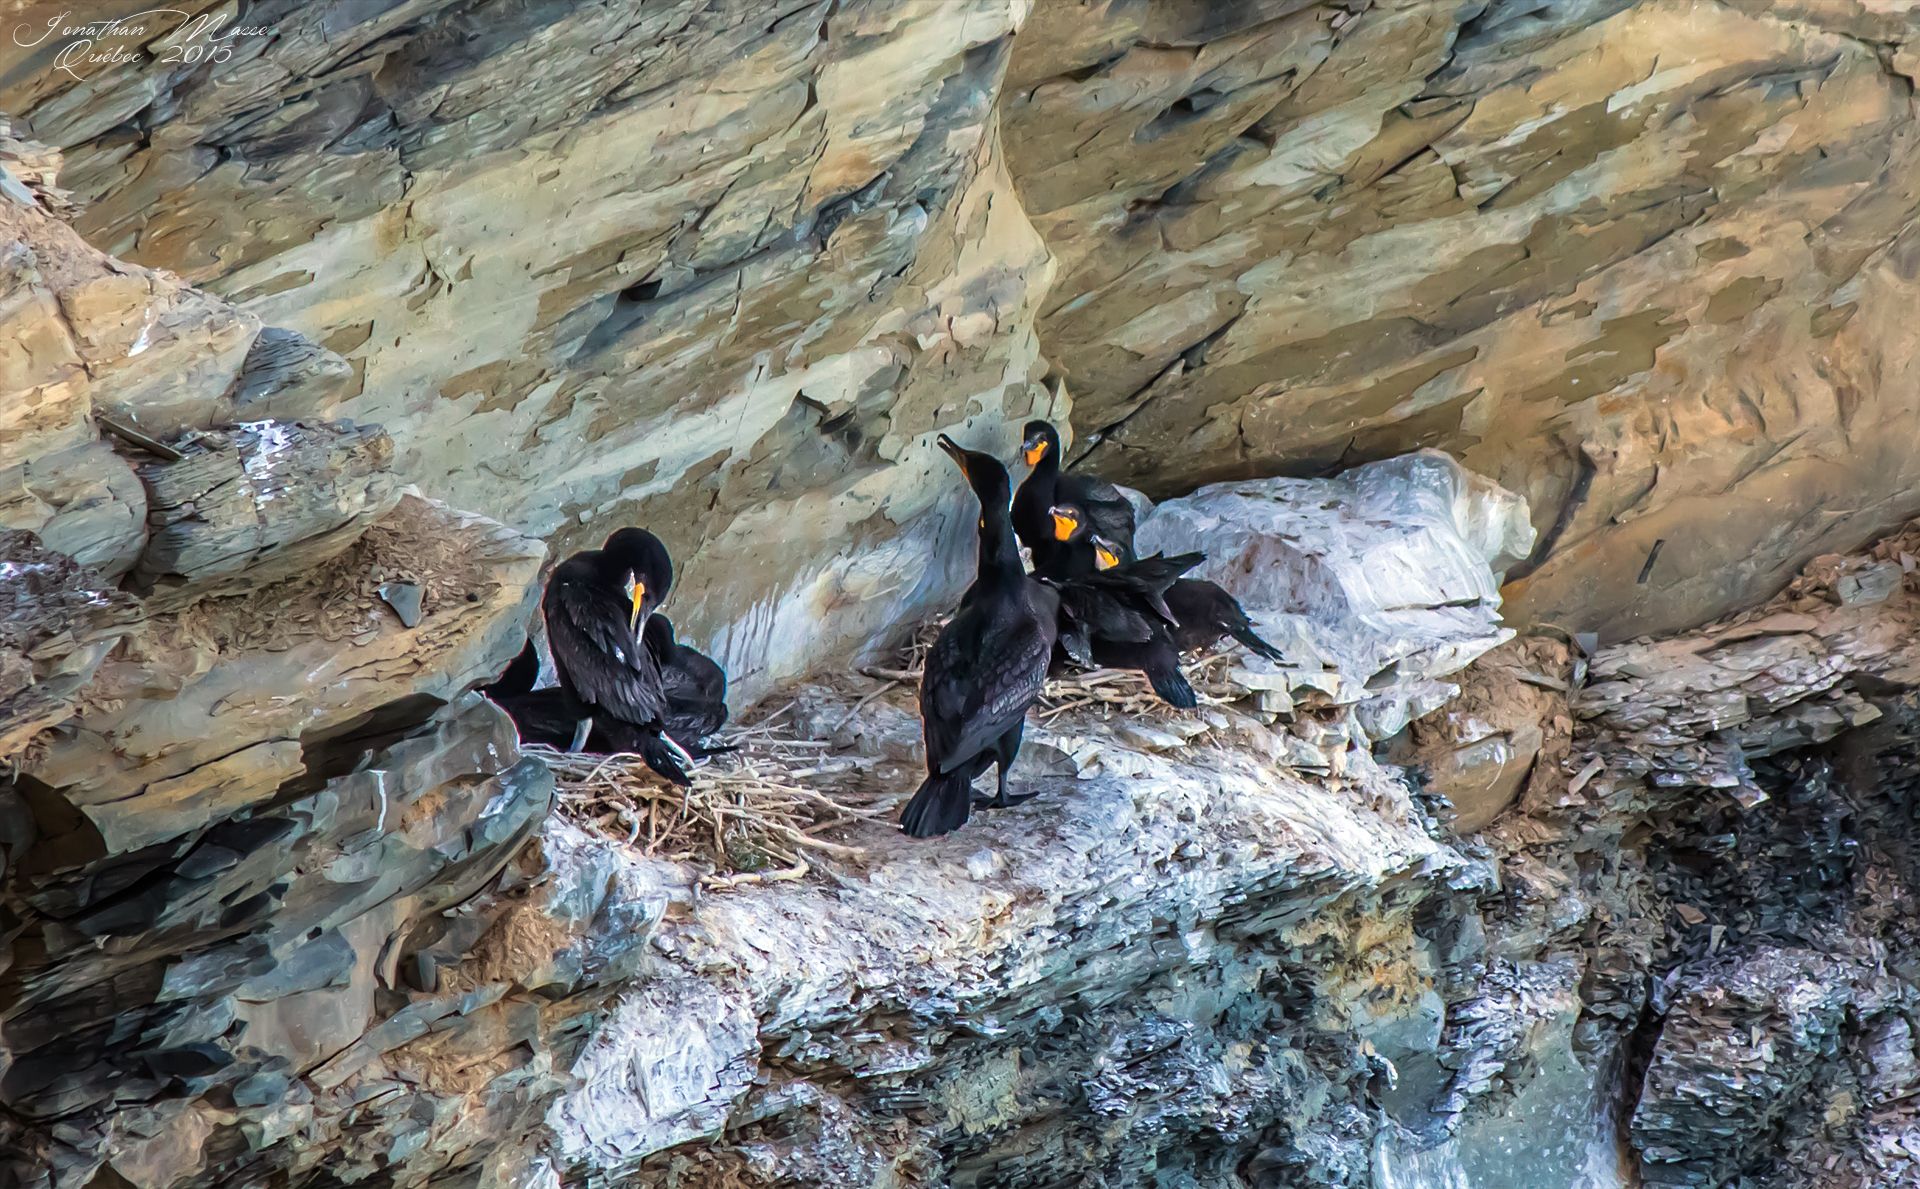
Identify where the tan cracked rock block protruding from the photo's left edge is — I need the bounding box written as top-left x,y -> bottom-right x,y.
0,124 -> 360,578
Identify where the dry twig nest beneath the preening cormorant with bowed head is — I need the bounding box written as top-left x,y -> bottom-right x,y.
524,724 -> 893,887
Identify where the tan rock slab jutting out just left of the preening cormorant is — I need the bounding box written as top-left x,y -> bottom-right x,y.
25,496 -> 545,851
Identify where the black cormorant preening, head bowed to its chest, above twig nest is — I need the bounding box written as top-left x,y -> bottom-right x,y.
541,528 -> 693,784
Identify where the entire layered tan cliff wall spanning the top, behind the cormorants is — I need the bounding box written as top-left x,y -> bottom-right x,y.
0,0 -> 1920,668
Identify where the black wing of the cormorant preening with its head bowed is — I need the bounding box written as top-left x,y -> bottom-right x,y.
541,565 -> 666,726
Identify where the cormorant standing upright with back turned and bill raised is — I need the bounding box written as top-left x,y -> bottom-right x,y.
900,434 -> 1060,837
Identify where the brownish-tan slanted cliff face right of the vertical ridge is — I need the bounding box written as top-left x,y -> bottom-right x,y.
1002,0 -> 1920,638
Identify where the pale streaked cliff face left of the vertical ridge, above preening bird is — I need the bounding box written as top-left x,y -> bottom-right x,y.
0,0 -> 1052,695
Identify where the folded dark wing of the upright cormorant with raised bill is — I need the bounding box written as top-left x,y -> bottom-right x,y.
920,613 -> 1054,772
